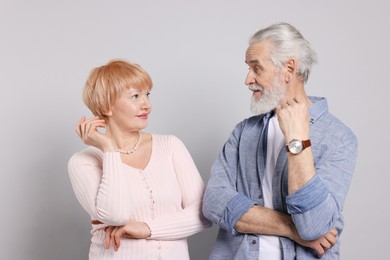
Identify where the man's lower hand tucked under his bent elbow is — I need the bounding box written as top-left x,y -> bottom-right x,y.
294,228 -> 337,258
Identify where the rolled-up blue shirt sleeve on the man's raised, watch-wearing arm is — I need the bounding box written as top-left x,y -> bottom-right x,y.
286,129 -> 357,240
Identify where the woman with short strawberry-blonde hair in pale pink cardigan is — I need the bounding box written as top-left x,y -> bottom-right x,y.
68,60 -> 211,260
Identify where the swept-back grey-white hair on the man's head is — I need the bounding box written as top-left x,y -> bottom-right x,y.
249,23 -> 317,83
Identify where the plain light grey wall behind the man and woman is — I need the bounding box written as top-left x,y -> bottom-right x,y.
0,0 -> 390,260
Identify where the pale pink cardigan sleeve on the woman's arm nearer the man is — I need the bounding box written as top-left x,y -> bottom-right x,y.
146,136 -> 212,240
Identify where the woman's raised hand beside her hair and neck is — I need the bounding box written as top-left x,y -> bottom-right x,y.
76,116 -> 115,152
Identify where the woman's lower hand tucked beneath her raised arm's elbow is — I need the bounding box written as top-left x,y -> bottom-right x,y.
105,220 -> 151,251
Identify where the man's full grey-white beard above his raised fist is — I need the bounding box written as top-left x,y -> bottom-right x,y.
251,79 -> 286,115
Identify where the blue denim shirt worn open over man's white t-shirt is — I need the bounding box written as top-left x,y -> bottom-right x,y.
203,97 -> 357,260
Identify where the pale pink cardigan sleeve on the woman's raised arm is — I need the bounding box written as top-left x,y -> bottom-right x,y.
68,148 -> 131,226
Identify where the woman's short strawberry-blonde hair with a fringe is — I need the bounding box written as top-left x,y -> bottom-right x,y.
83,60 -> 153,119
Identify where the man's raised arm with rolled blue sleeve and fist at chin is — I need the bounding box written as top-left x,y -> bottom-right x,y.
276,99 -> 357,240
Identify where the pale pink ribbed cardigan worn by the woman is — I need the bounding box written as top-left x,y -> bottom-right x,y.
68,134 -> 211,260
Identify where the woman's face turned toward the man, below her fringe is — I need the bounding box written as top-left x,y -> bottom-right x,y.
109,88 -> 152,131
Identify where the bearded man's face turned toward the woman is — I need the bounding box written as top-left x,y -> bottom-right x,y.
245,42 -> 286,114
